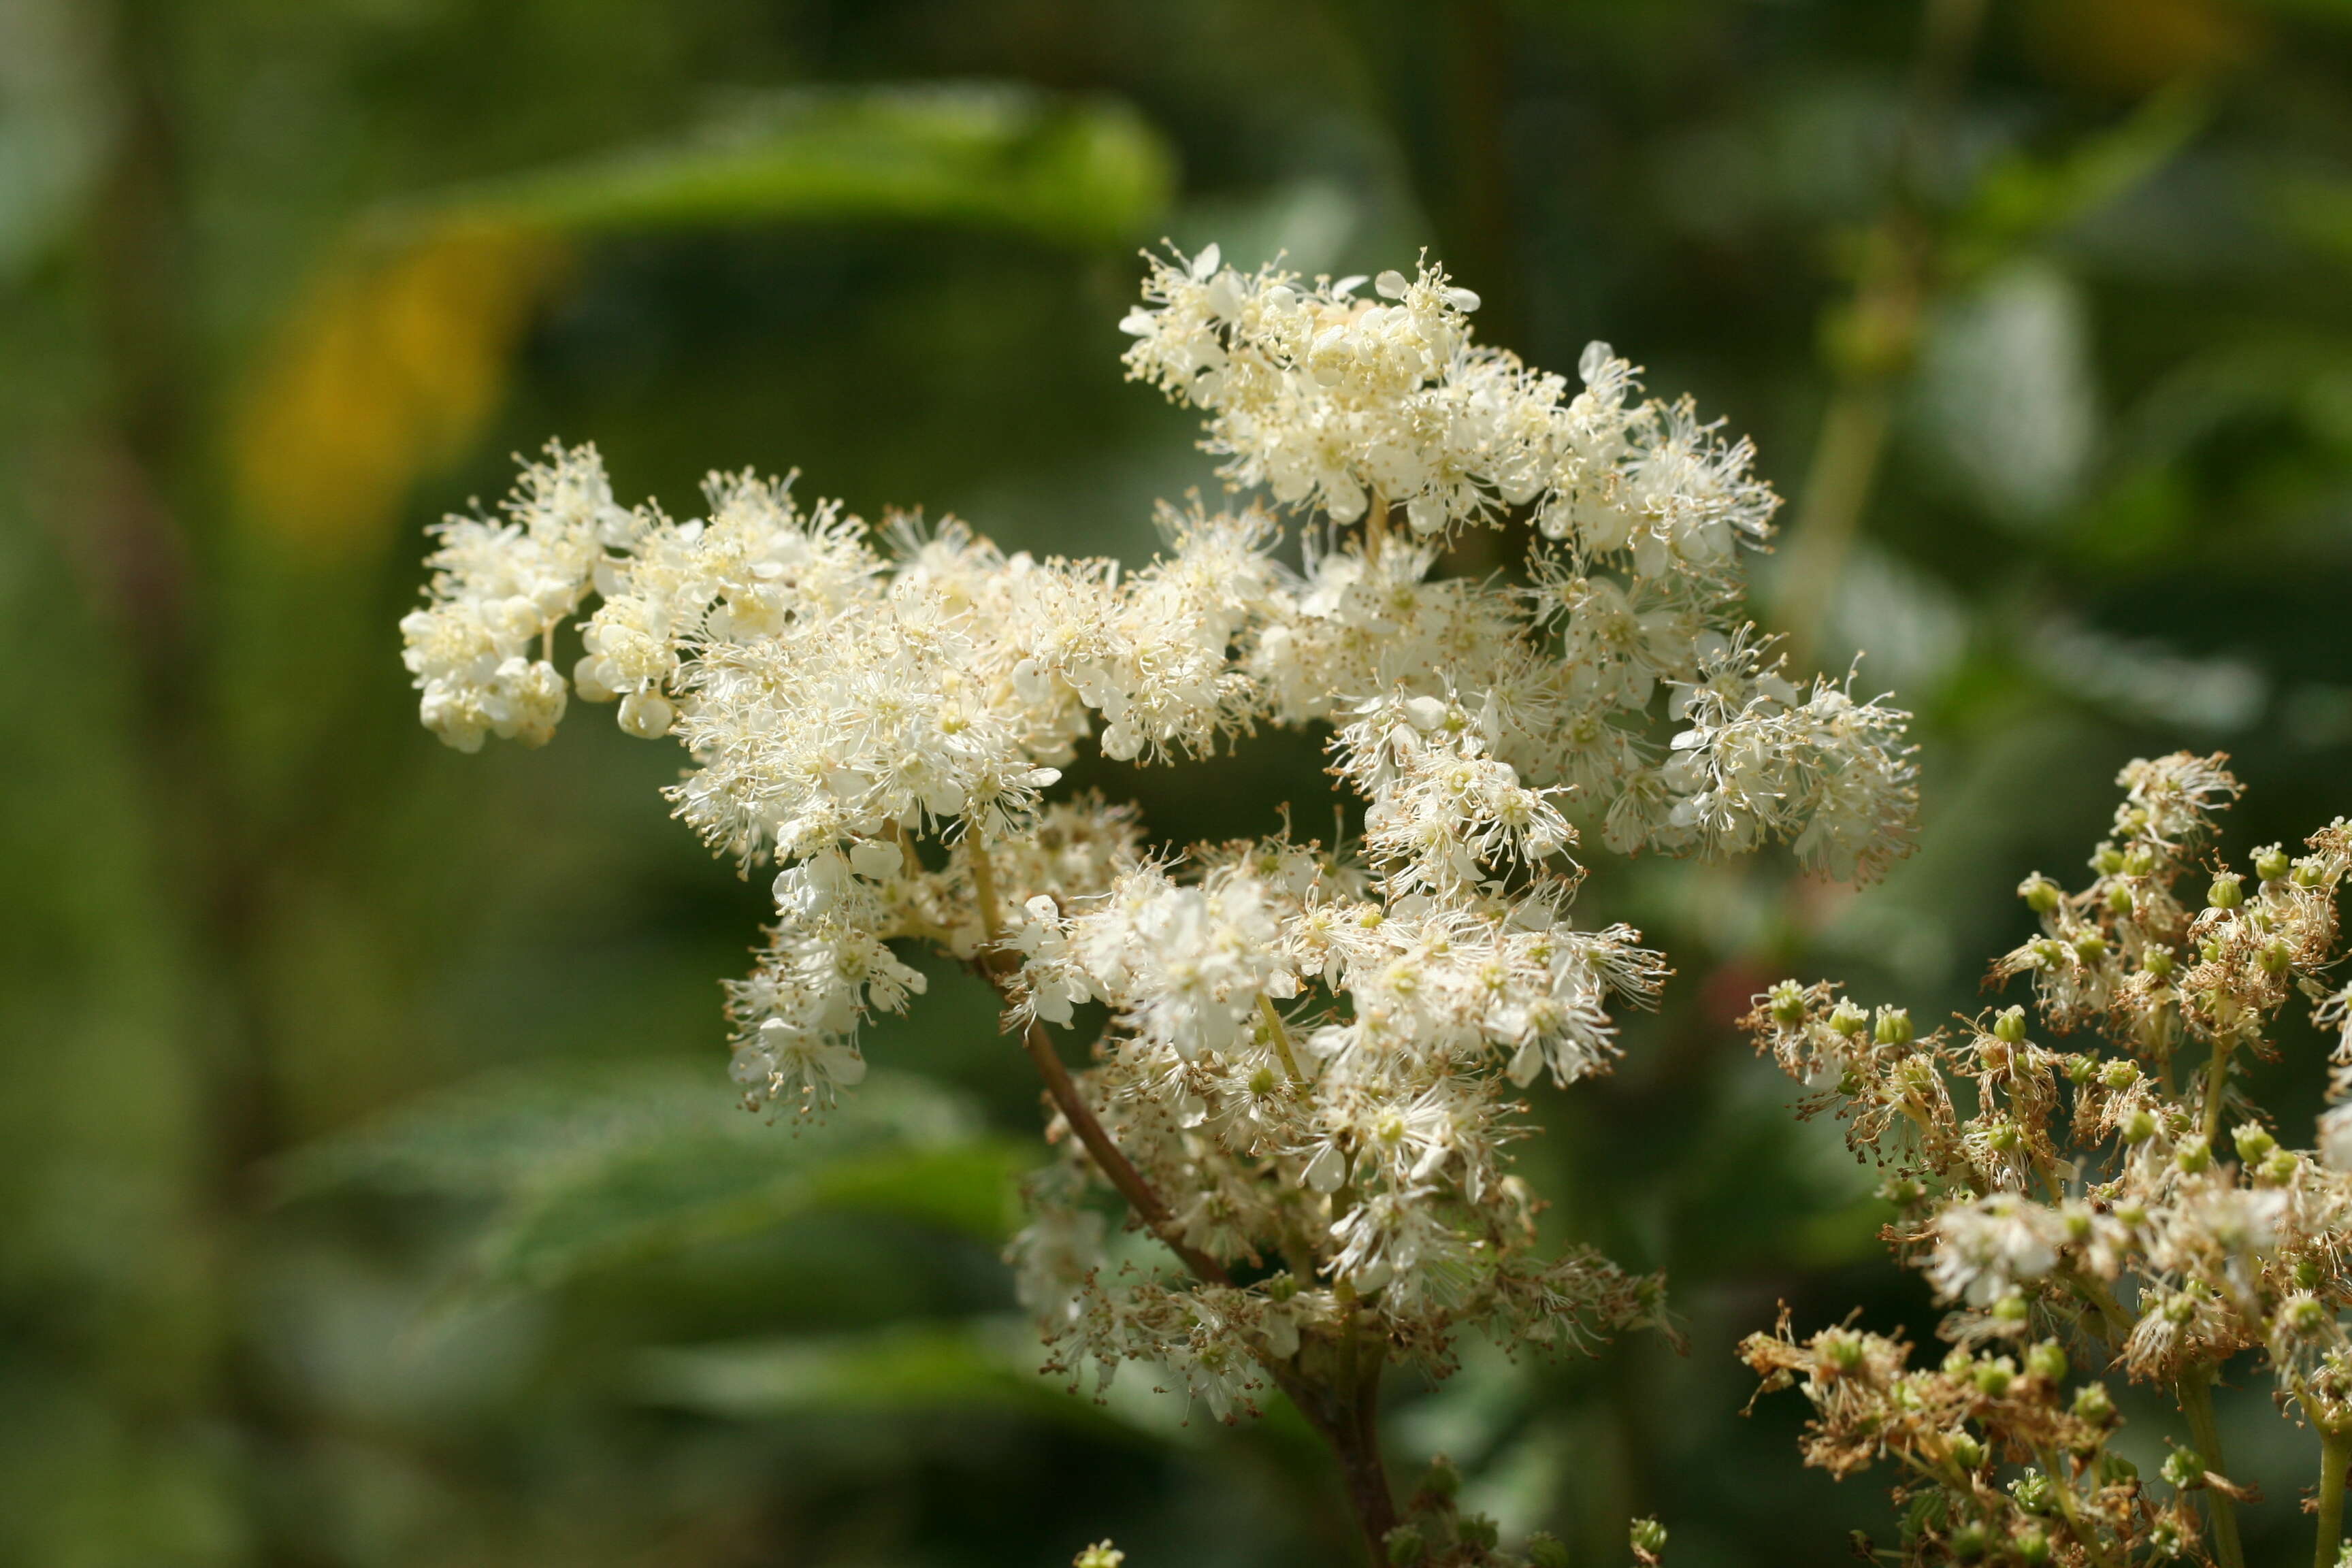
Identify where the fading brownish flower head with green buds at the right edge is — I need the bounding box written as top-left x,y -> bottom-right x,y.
1745,755 -> 2352,1568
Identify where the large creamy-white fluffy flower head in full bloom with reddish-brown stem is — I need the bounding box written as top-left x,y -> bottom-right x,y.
402,247 -> 1912,1561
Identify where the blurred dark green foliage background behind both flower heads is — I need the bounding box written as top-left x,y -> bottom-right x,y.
14,0 -> 2352,1568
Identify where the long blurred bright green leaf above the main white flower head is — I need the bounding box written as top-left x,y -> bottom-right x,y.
364,84 -> 1174,244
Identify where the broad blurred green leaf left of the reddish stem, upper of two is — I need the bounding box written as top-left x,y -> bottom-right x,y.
280,1065 -> 1030,1295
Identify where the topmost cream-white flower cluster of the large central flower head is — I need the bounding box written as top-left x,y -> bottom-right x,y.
1120,244 -> 1778,557
